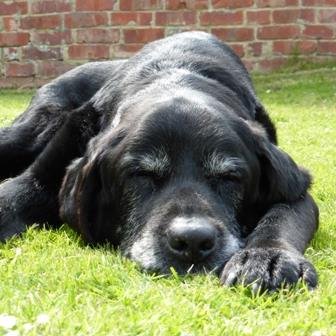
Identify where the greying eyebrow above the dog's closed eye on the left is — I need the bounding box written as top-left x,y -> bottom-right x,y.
139,148 -> 170,175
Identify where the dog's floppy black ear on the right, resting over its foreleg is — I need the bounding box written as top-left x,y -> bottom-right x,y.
248,122 -> 311,204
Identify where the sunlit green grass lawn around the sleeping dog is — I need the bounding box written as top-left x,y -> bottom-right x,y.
0,69 -> 336,336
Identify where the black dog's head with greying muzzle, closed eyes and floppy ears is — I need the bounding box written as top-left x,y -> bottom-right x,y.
60,91 -> 310,273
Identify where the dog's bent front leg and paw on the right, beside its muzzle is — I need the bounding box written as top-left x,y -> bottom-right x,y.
221,194 -> 318,290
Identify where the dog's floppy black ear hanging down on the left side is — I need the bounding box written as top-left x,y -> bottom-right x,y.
59,138 -> 121,244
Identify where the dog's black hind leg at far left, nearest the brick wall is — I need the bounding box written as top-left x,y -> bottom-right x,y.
0,61 -> 125,181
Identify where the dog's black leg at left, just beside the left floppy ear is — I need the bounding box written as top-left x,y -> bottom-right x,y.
0,104 -> 99,241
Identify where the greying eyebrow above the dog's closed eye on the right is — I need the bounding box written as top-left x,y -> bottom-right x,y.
203,152 -> 246,176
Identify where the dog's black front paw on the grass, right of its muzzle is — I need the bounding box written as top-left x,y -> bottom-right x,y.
221,248 -> 317,292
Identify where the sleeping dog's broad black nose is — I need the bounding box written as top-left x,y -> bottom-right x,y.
167,217 -> 217,263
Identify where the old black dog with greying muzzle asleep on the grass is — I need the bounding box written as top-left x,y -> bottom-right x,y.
0,32 -> 318,290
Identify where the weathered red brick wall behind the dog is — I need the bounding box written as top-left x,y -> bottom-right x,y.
0,0 -> 336,87
